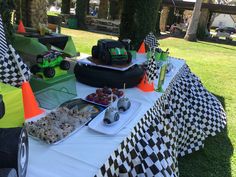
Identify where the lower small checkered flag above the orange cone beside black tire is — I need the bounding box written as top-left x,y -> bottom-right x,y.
146,53 -> 158,83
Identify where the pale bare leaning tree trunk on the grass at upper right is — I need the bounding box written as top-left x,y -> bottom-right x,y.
184,0 -> 202,41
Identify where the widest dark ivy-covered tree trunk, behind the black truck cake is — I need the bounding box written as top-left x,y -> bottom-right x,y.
120,0 -> 160,49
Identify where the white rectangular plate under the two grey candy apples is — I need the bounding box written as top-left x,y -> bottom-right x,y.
88,100 -> 141,135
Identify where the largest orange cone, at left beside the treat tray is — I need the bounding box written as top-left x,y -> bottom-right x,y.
21,82 -> 44,119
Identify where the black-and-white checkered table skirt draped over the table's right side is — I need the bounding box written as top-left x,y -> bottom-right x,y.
96,65 -> 226,177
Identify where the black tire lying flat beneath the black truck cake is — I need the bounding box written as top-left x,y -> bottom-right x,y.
74,63 -> 144,89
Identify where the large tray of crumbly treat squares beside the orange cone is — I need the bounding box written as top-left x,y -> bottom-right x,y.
25,99 -> 104,144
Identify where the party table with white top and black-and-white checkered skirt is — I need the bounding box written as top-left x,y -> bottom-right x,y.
27,57 -> 226,177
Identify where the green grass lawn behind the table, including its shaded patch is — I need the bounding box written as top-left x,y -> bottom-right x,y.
62,28 -> 236,177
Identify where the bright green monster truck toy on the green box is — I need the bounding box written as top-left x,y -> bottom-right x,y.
31,50 -> 70,78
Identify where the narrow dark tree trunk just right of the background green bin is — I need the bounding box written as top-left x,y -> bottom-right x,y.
76,0 -> 88,29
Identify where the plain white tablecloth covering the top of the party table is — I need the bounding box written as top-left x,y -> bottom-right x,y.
27,58 -> 185,177
